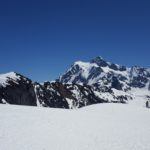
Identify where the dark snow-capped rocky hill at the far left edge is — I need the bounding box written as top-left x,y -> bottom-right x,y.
0,72 -> 36,106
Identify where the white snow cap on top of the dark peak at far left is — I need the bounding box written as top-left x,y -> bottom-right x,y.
0,72 -> 20,87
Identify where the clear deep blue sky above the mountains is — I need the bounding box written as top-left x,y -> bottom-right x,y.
0,0 -> 150,81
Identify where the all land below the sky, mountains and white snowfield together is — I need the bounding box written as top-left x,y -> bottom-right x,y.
0,57 -> 150,150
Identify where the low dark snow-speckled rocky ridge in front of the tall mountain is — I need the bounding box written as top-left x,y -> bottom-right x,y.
35,82 -> 107,109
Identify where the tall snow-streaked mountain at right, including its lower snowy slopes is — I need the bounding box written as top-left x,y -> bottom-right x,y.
59,57 -> 150,105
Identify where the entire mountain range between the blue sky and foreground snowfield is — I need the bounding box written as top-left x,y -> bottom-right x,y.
0,57 -> 150,108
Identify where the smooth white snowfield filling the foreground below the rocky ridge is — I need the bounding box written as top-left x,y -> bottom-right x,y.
0,104 -> 150,150
